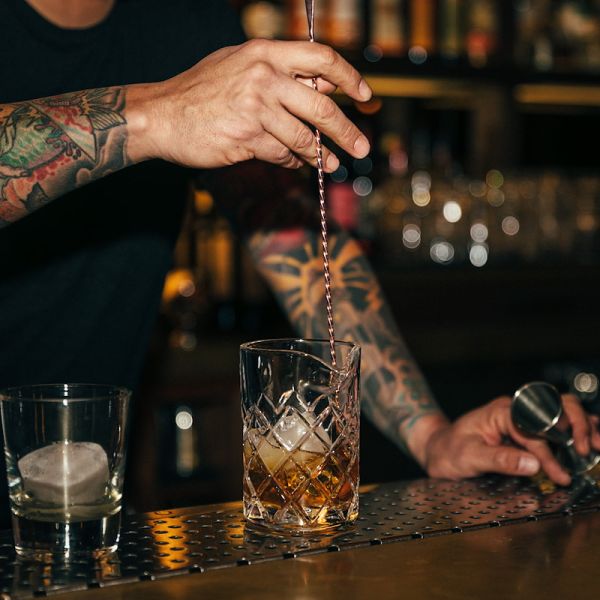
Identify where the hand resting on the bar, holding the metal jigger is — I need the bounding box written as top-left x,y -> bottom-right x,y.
424,394 -> 600,485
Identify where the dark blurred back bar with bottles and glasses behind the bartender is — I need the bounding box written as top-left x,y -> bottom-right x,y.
128,0 -> 600,510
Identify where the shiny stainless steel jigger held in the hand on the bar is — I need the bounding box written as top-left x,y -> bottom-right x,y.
511,381 -> 600,486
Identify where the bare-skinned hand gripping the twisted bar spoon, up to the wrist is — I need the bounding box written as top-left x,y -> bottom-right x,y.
127,40 -> 371,171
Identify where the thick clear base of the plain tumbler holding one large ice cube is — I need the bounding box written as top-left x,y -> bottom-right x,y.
12,511 -> 121,562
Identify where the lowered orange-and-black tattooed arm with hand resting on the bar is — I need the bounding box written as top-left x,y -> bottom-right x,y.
249,229 -> 600,485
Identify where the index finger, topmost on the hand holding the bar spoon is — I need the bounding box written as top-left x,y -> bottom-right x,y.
277,42 -> 373,102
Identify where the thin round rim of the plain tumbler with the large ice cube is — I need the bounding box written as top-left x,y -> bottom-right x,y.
0,383 -> 133,403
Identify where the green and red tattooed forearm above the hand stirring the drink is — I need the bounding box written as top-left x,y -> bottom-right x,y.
0,88 -> 129,227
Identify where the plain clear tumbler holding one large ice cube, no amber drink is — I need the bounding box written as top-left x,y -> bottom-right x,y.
0,384 -> 131,559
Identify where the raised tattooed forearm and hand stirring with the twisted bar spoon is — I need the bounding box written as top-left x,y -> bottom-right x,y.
0,40 -> 371,226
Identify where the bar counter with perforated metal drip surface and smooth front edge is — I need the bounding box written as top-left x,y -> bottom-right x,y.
0,477 -> 600,600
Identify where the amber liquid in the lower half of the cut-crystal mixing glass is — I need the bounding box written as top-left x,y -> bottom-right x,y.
244,442 -> 358,530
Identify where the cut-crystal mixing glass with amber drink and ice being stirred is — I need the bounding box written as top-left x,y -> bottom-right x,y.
240,339 -> 360,532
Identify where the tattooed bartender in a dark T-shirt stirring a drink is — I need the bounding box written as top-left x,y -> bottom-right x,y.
0,0 -> 600,496
